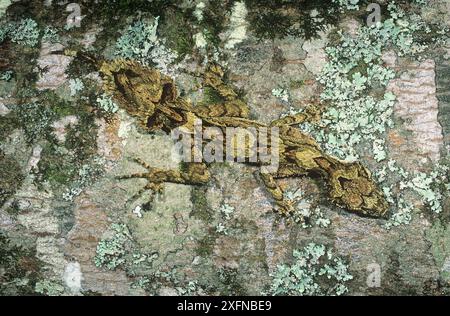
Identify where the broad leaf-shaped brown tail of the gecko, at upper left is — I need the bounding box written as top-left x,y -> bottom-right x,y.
100,59 -> 177,130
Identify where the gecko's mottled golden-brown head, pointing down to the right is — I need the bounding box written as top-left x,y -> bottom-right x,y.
330,163 -> 388,218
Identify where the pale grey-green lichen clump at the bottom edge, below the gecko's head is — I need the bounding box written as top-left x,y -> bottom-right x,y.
269,243 -> 353,296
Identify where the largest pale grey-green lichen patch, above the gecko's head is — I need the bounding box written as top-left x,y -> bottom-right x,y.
302,2 -> 446,161
